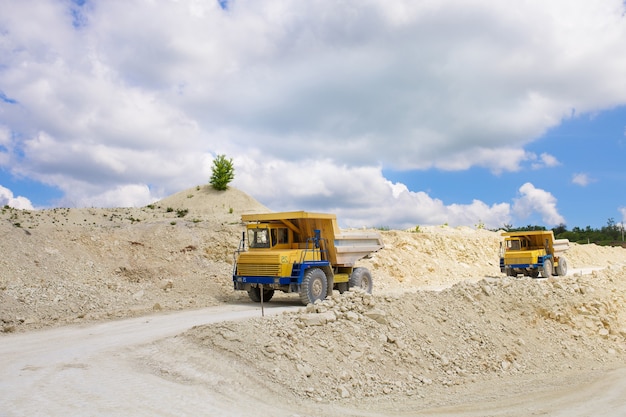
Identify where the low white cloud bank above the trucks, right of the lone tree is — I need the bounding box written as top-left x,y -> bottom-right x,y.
233,159 -> 511,229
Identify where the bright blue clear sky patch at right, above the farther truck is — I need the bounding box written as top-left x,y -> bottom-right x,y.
384,107 -> 626,229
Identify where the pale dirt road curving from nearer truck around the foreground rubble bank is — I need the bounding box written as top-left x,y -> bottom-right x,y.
0,303 -> 626,417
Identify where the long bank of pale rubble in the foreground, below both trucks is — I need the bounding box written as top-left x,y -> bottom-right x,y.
178,268 -> 626,401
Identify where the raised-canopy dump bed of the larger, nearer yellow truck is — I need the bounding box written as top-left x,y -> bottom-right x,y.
241,211 -> 384,266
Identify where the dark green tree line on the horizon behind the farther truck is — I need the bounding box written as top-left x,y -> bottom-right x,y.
504,218 -> 626,247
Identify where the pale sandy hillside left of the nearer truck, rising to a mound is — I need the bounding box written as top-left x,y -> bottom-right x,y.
0,186 -> 267,332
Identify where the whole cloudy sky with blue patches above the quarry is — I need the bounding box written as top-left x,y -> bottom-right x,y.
0,0 -> 626,228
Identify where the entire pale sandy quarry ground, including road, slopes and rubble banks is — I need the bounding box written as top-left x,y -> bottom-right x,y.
0,187 -> 626,417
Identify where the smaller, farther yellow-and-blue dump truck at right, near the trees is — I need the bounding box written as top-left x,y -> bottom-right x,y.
500,231 -> 569,278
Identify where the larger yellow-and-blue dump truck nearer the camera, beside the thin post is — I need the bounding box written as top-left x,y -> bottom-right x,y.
233,211 -> 384,305
